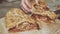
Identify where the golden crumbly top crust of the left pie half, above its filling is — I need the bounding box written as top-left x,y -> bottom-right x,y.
5,8 -> 38,30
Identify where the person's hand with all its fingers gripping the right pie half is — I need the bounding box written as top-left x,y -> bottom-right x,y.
20,0 -> 39,13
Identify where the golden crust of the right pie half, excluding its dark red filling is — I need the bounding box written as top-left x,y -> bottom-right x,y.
31,0 -> 56,19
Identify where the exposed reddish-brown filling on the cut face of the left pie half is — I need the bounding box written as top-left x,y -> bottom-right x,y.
8,22 -> 38,32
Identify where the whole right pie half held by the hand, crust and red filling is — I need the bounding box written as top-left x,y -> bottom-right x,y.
31,0 -> 56,23
